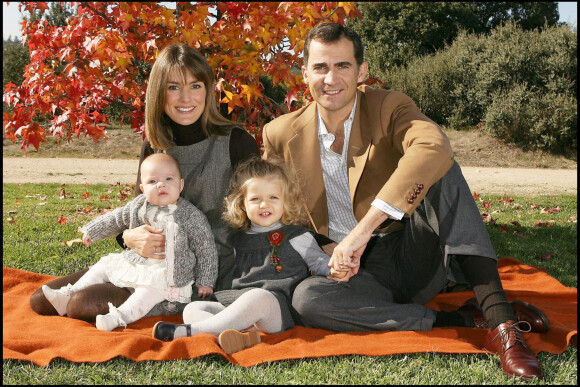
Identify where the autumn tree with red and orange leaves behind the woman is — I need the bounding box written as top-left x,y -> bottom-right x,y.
3,2 -> 360,151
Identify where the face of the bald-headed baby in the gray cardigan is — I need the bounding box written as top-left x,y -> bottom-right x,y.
139,154 -> 184,206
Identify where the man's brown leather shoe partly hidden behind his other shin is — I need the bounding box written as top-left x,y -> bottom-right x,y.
457,297 -> 550,333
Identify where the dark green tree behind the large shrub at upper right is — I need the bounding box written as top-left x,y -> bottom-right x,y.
348,2 -> 559,77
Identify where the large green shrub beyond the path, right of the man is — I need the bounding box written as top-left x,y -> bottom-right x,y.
384,22 -> 577,154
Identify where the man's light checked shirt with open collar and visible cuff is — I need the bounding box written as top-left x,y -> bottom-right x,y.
317,96 -> 404,242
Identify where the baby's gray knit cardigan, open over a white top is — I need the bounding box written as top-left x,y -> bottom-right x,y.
82,194 -> 218,287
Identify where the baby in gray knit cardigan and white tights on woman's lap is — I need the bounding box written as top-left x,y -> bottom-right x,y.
42,153 -> 218,331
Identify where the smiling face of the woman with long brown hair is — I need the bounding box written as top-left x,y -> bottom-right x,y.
165,69 -> 207,125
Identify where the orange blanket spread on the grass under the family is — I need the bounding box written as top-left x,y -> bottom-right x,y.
2,258 -> 577,367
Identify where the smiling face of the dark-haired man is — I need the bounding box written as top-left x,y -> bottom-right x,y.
302,37 -> 368,118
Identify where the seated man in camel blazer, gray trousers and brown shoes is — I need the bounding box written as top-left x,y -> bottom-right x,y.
263,23 -> 549,378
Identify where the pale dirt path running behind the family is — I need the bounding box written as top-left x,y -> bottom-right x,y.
2,157 -> 578,195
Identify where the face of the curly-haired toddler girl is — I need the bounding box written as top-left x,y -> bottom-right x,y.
244,176 -> 284,227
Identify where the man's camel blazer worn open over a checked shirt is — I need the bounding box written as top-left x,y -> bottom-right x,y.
263,85 -> 453,236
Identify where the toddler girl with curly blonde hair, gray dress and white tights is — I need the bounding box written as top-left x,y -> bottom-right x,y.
153,158 -> 346,354
